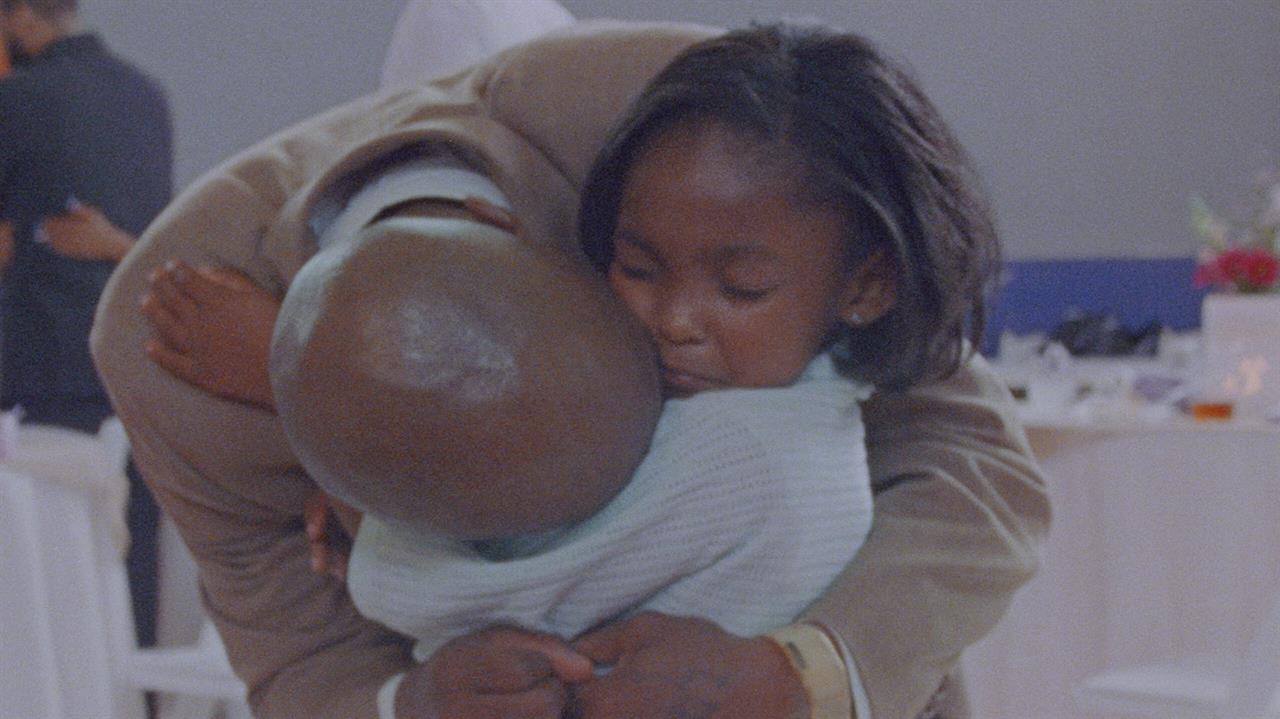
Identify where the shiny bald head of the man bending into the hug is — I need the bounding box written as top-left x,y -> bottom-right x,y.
271,217 -> 659,539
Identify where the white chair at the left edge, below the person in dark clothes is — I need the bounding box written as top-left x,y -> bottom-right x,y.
0,420 -> 250,719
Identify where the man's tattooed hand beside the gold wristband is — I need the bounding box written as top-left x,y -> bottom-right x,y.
573,612 -> 809,719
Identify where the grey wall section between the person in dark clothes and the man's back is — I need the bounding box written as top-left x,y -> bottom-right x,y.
81,0 -> 404,187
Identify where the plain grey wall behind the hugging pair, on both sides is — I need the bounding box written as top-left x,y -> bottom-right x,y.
82,0 -> 1280,257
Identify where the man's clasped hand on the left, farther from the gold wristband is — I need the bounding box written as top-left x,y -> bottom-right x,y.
396,627 -> 591,719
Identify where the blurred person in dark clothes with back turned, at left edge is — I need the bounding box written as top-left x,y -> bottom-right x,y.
0,0 -> 172,645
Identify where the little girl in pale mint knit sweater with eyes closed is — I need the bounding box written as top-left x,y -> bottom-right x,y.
142,20 -> 998,701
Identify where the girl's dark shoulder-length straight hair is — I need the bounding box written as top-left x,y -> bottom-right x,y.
579,24 -> 1000,388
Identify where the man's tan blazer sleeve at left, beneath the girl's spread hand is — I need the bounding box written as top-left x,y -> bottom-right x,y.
91,92 -> 422,719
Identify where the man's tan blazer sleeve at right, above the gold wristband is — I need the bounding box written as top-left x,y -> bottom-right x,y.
805,356 -> 1050,719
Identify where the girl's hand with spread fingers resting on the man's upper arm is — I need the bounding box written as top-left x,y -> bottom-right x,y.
142,261 -> 280,411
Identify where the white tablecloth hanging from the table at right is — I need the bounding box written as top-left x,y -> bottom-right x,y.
965,420 -> 1280,719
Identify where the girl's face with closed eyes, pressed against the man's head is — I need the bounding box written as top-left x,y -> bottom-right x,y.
608,124 -> 860,397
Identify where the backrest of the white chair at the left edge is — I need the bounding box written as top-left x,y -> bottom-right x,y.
0,463 -> 145,719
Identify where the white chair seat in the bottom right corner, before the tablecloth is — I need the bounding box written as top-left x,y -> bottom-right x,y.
1076,588 -> 1280,719
